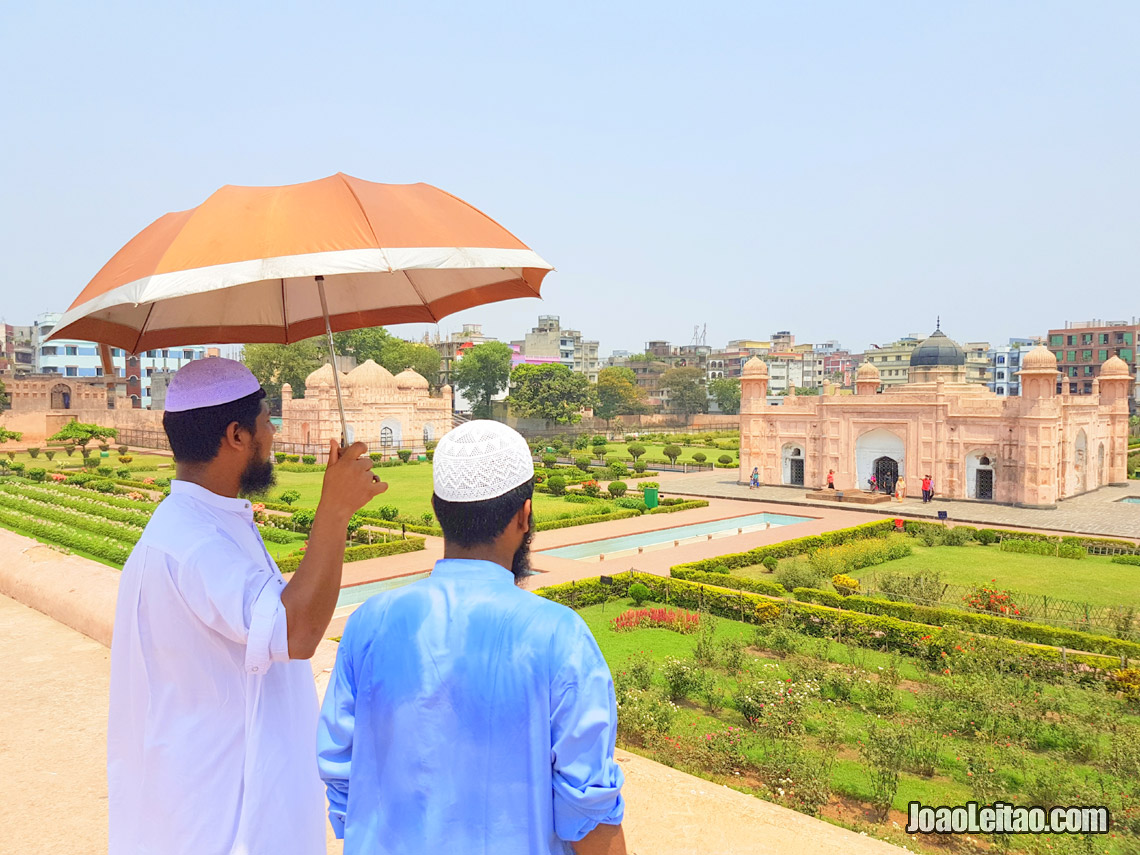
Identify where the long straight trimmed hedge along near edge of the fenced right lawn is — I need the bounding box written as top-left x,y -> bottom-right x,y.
792,588 -> 1140,659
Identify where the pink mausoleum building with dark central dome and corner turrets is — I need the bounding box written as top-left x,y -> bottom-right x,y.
740,329 -> 1132,507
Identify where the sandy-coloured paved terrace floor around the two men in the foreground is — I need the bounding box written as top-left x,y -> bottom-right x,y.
0,596 -> 903,855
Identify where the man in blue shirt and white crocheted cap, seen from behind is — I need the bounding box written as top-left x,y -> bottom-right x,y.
317,421 -> 626,855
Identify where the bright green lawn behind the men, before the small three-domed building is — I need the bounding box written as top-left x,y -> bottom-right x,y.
269,463 -> 613,522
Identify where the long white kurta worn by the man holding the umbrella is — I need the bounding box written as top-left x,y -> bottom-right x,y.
107,481 -> 325,855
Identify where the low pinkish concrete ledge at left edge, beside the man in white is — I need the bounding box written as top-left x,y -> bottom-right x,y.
0,529 -> 119,646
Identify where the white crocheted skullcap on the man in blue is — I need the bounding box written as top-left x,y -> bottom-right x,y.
432,420 -> 535,502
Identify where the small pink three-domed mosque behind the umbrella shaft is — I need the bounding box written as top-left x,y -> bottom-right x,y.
274,359 -> 453,457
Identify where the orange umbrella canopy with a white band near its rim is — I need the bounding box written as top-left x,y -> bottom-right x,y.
50,173 -> 553,353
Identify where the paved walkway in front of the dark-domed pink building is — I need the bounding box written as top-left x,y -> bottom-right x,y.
659,470 -> 1140,539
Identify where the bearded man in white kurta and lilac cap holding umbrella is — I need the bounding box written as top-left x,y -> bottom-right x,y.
107,358 -> 385,855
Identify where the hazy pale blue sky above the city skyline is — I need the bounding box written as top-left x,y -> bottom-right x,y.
0,0 -> 1140,355
